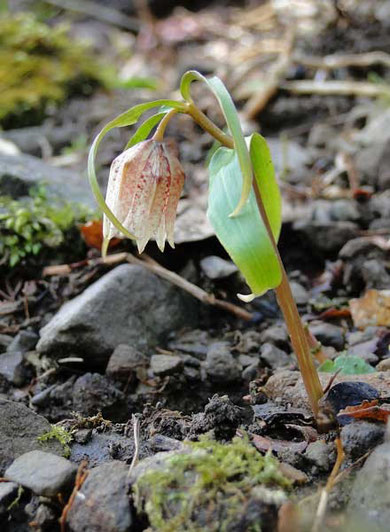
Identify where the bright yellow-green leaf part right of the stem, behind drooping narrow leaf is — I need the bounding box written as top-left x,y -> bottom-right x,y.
249,133 -> 282,242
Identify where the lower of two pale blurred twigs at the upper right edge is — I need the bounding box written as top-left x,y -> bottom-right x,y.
280,80 -> 390,98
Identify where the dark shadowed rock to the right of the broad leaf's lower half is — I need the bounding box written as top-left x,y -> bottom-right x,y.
293,220 -> 359,254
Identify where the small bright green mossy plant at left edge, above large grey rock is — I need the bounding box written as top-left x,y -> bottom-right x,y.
0,187 -> 91,267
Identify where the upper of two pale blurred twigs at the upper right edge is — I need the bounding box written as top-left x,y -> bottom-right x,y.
292,51 -> 390,70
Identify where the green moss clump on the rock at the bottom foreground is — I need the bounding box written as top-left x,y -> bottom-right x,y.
134,438 -> 290,532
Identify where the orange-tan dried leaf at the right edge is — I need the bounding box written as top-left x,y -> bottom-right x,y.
349,289 -> 390,329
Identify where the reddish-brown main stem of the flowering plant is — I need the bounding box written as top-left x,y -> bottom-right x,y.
187,103 -> 323,415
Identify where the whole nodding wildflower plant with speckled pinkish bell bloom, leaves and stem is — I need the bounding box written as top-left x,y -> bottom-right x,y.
88,71 -> 323,413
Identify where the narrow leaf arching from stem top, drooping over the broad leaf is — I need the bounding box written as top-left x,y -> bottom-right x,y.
180,70 -> 253,217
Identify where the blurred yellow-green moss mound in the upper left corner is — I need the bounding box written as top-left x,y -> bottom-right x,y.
0,13 -> 108,127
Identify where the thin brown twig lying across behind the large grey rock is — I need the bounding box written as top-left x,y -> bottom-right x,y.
42,253 -> 253,321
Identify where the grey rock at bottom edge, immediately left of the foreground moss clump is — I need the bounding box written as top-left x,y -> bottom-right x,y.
67,461 -> 133,532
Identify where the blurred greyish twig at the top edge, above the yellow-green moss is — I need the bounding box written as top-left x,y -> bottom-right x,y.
45,0 -> 139,31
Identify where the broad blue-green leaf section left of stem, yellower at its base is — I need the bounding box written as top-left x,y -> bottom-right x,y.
207,148 -> 282,296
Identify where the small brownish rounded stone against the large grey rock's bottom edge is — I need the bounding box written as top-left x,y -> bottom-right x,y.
106,344 -> 148,382
